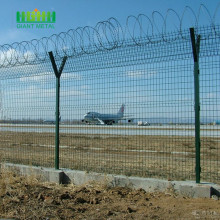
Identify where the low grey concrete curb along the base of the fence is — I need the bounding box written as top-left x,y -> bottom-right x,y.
0,163 -> 220,198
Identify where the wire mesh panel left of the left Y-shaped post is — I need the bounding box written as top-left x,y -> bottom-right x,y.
0,64 -> 55,167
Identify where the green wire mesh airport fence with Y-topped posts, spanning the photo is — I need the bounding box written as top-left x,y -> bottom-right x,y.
0,6 -> 220,183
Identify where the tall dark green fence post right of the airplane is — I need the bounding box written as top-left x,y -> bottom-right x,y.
190,28 -> 201,183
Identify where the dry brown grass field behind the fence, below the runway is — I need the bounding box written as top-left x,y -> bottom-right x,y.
0,132 -> 220,183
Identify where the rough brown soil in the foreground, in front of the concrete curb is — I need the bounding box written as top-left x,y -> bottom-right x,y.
0,170 -> 220,220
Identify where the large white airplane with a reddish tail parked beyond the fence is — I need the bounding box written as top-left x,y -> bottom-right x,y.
82,104 -> 132,125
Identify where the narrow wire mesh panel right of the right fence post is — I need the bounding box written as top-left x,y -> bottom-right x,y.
200,42 -> 220,183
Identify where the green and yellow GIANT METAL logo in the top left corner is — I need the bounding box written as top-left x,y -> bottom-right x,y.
16,9 -> 56,29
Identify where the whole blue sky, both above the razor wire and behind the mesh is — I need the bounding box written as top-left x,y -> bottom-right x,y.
0,0 -> 220,122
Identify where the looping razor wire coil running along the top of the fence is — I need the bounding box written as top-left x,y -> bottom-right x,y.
0,3 -> 220,67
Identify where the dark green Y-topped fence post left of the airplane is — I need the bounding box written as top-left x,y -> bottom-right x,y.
49,51 -> 67,170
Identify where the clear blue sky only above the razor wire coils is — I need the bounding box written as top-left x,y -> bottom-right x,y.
0,0 -> 219,45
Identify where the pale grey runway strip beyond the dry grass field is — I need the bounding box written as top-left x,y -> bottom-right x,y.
0,124 -> 220,137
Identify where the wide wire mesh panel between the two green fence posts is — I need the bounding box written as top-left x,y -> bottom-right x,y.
56,35 -> 195,179
